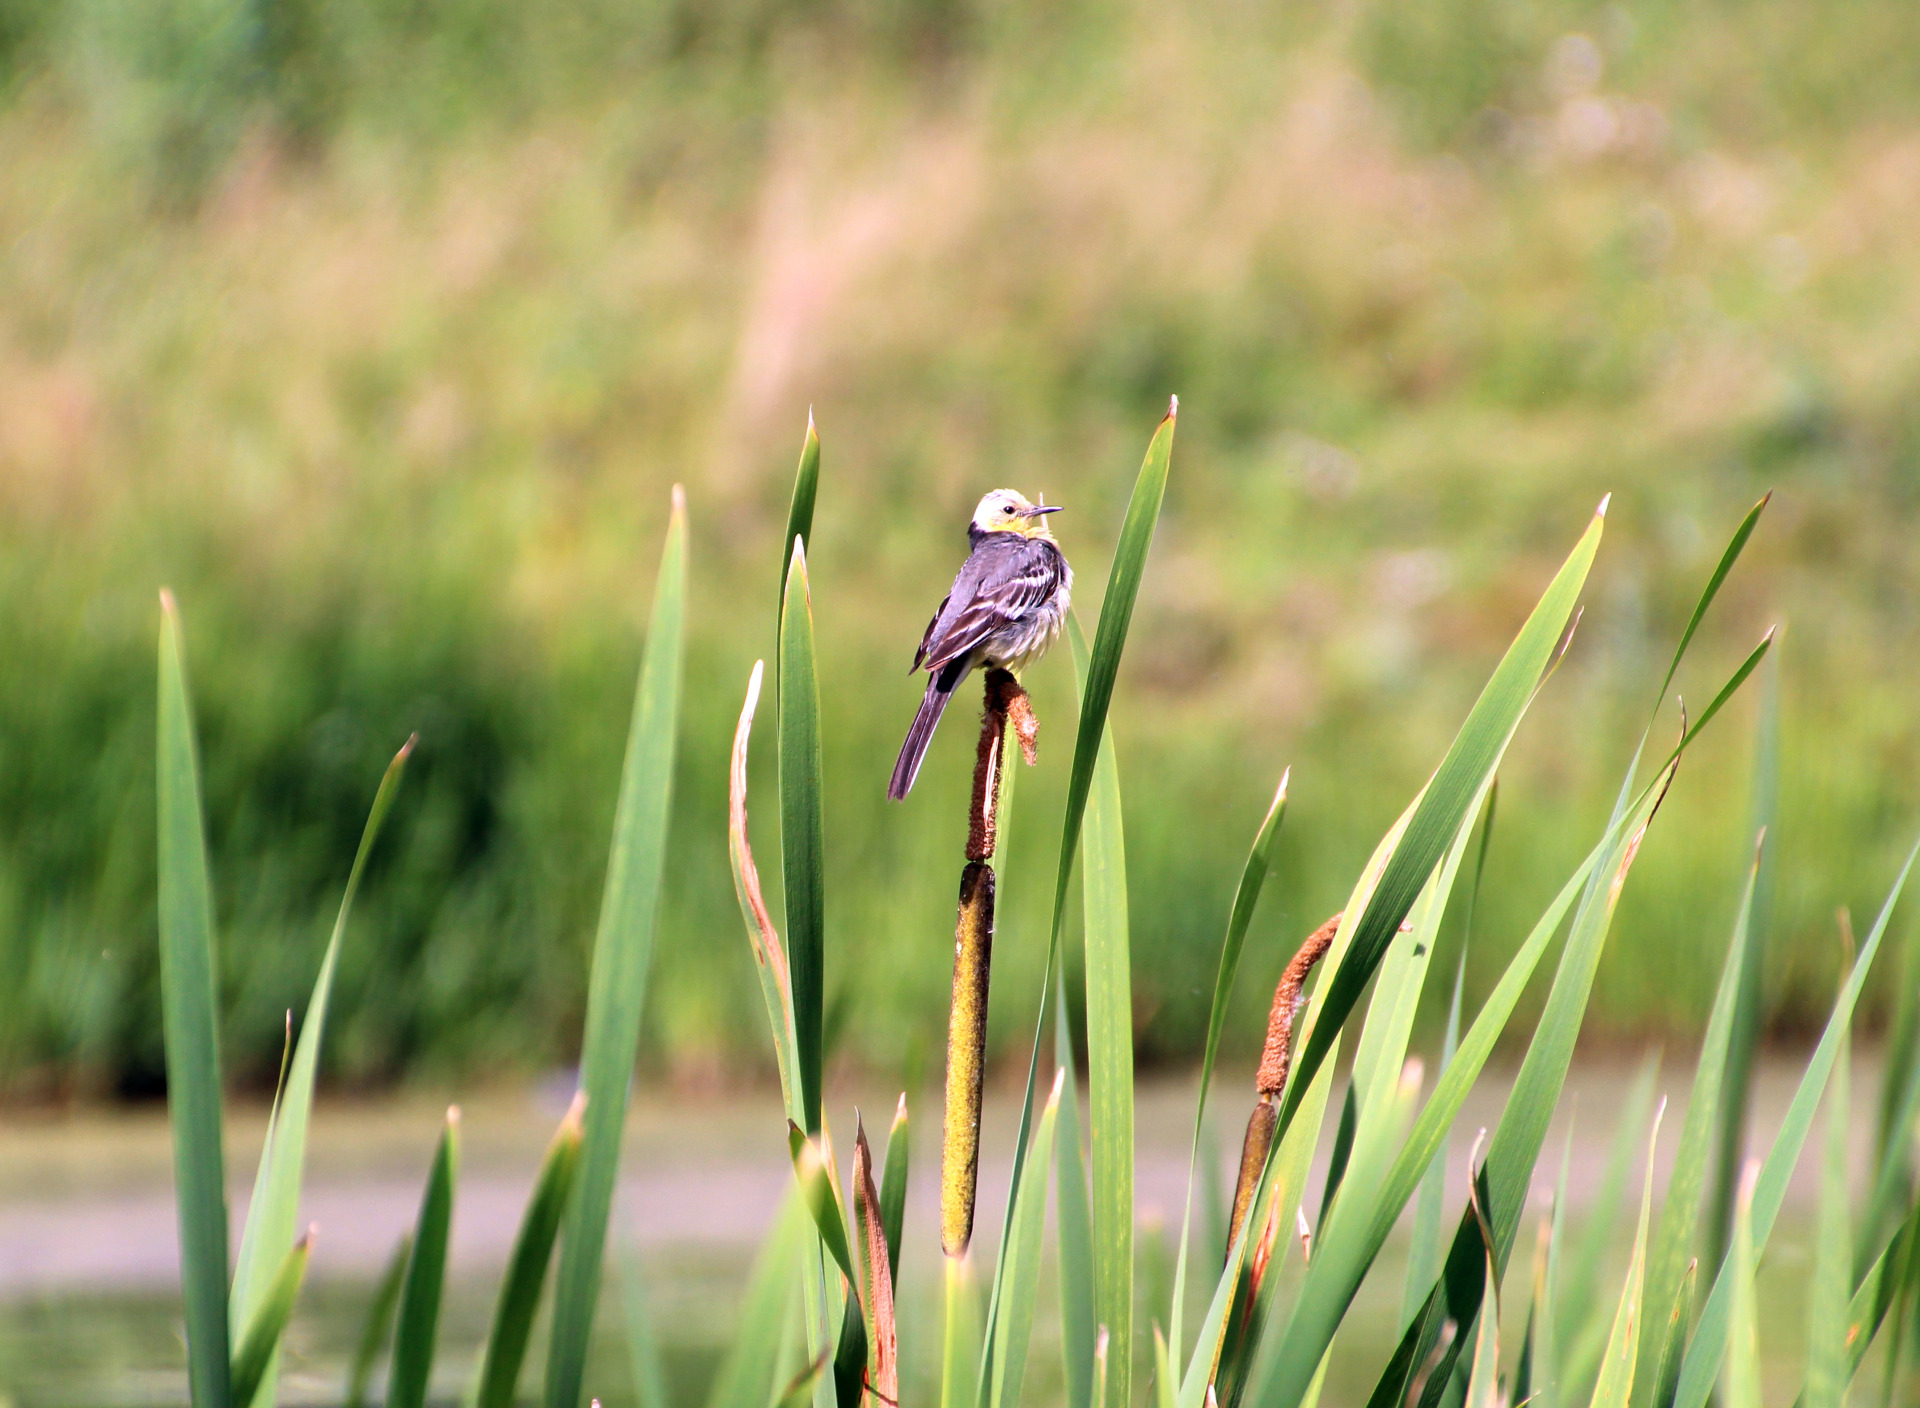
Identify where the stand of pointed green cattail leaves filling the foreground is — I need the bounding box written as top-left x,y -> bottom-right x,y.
157,428 -> 1920,1408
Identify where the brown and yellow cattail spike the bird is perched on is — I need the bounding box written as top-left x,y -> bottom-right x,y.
941,668 -> 1039,1256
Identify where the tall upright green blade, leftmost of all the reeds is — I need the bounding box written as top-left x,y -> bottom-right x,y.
156,592 -> 230,1408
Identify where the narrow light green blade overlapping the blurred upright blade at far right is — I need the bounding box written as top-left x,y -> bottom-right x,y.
1634,836 -> 1766,1406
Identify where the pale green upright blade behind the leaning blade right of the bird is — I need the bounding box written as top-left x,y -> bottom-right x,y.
1081,637 -> 1133,1408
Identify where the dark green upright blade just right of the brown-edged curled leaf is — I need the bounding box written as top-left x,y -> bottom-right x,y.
780,538 -> 826,1133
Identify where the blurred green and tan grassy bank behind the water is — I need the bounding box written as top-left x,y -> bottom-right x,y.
0,0 -> 1920,1101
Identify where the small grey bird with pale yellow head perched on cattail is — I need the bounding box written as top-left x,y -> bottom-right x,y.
887,490 -> 1073,801
